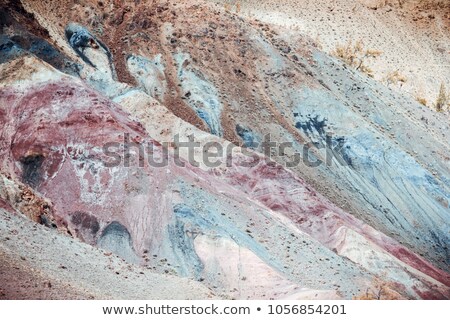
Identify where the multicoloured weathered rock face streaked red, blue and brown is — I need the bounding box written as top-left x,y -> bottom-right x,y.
0,1 -> 450,298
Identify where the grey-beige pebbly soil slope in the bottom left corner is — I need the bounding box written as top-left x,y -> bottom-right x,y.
0,209 -> 217,300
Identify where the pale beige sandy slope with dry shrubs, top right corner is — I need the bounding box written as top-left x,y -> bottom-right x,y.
213,0 -> 450,108
